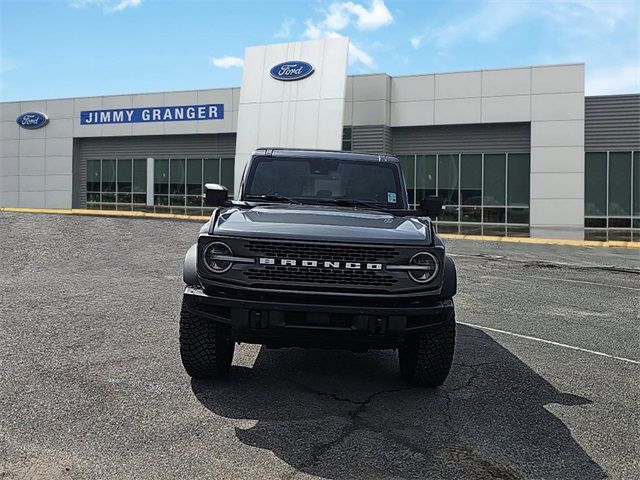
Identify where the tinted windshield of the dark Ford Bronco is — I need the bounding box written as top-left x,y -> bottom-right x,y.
244,157 -> 406,209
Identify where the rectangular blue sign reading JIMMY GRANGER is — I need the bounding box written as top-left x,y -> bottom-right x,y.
80,103 -> 224,125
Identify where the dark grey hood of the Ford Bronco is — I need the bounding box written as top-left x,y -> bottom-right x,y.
214,205 -> 432,245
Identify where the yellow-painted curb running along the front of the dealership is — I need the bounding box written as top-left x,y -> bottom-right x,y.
0,207 -> 640,249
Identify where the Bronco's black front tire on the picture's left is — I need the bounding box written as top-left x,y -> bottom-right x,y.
180,300 -> 235,378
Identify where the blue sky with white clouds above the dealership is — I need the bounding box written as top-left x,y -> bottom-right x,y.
0,0 -> 640,101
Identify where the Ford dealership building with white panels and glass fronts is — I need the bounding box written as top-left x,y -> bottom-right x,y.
0,38 -> 640,241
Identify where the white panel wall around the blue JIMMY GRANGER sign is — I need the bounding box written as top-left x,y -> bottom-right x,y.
0,88 -> 240,208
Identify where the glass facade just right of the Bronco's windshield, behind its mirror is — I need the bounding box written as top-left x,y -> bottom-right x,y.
398,153 -> 531,236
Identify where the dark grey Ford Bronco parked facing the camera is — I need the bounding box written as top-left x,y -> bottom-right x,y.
180,148 -> 456,386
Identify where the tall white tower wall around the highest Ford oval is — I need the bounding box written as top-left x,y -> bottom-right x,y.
235,38 -> 349,192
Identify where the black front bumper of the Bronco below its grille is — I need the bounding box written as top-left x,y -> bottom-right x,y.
183,287 -> 454,350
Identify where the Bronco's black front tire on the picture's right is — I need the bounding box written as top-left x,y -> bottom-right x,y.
399,318 -> 456,387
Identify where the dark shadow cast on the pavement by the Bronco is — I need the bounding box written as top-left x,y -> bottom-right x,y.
192,325 -> 606,479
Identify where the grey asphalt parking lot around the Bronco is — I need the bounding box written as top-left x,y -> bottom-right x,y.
0,213 -> 640,479
